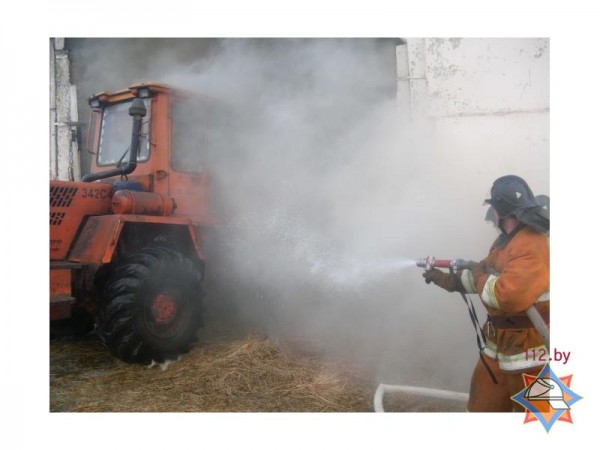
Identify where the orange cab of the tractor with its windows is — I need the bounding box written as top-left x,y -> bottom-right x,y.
83,83 -> 229,221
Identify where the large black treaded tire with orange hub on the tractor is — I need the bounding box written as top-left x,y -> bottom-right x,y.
96,247 -> 203,364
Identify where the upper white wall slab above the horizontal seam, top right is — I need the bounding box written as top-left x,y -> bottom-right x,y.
422,39 -> 549,116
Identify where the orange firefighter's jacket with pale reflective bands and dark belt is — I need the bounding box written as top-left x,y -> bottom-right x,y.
461,226 -> 550,371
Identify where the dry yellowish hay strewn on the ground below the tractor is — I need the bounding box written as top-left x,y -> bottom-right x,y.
50,335 -> 373,412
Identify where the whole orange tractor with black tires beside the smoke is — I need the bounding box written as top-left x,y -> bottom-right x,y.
50,83 -> 219,363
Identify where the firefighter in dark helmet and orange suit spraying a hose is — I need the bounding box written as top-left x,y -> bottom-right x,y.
423,175 -> 550,412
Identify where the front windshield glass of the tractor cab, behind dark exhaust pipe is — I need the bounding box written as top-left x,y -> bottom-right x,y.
98,99 -> 150,166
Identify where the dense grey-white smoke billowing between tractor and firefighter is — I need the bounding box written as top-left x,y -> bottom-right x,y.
69,39 -> 538,391
